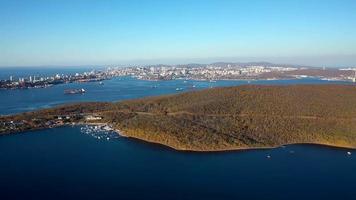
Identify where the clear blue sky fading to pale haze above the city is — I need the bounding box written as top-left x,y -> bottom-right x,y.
0,0 -> 356,67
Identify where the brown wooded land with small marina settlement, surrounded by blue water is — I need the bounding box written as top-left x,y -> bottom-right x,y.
0,85 -> 356,151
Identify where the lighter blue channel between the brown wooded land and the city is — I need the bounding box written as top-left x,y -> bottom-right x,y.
0,77 -> 345,115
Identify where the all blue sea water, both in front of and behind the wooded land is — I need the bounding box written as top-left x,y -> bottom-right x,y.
0,69 -> 356,199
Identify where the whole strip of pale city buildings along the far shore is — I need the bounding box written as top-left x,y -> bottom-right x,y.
0,63 -> 356,89
